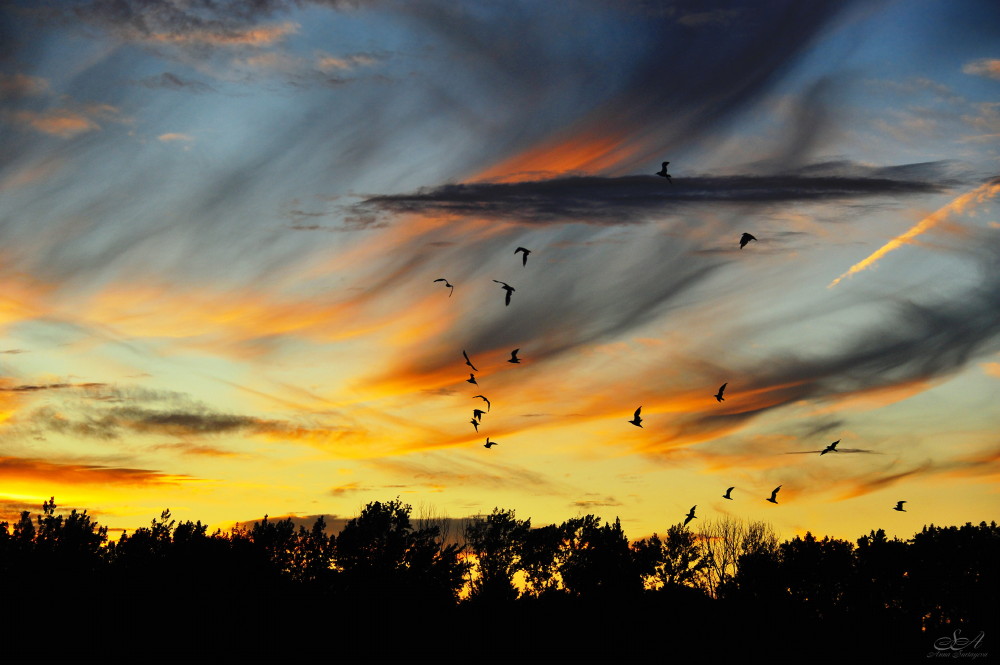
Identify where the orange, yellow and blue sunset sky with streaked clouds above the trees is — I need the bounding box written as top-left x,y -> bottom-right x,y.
0,0 -> 1000,539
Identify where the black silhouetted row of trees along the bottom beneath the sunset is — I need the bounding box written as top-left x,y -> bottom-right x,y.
0,499 -> 1000,662
